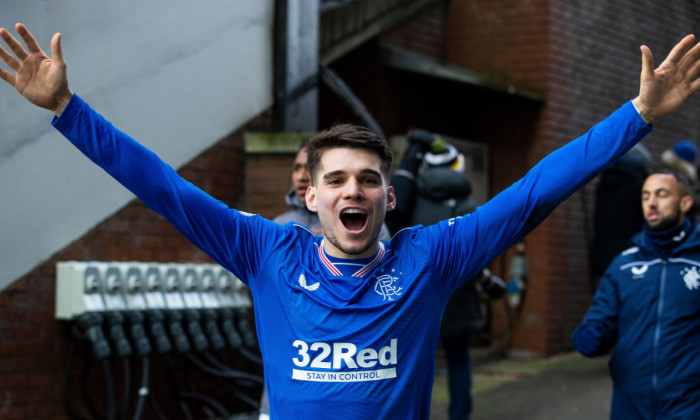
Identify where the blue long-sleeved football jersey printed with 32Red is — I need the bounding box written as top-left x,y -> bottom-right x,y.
53,95 -> 651,420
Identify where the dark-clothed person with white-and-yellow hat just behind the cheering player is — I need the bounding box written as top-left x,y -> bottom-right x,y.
388,129 -> 506,420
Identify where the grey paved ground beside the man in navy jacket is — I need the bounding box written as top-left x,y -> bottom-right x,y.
430,352 -> 612,420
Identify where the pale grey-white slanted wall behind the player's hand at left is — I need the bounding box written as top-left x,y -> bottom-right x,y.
0,0 -> 274,290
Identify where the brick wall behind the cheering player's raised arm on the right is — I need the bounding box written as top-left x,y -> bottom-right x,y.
448,0 -> 700,354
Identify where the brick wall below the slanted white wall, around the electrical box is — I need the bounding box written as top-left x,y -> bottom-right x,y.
0,113 -> 269,419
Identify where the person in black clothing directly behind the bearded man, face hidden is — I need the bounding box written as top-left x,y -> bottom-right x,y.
590,144 -> 651,278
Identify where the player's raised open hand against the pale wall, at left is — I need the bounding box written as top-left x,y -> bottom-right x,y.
0,23 -> 73,115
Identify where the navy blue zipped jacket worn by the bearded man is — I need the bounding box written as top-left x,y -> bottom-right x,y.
572,226 -> 700,419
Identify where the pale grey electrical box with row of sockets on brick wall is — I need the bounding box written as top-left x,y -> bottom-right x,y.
56,261 -> 252,319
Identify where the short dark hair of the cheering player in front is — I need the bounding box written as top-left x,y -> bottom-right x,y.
306,124 -> 394,184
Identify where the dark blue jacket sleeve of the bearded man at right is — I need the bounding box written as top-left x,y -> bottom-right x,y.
571,266 -> 620,357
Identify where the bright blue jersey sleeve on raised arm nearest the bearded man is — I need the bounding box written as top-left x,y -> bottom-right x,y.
415,101 -> 652,290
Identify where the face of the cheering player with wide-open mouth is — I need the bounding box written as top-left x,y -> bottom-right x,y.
306,147 -> 396,258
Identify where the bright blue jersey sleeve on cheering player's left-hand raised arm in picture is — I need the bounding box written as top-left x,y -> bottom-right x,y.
52,95 -> 277,283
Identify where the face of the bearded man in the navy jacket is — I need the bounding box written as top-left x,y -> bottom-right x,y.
642,173 -> 693,231
